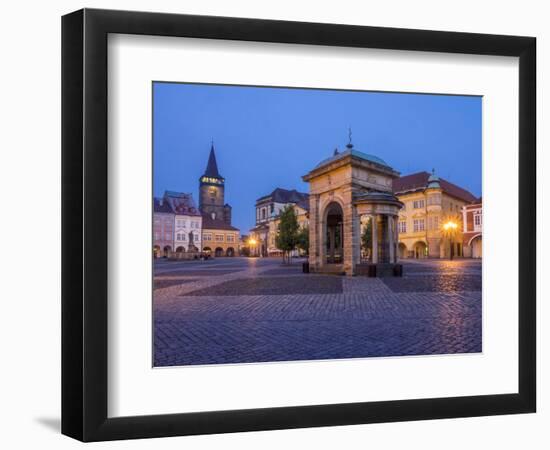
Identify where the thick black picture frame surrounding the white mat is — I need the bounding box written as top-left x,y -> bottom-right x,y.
62,9 -> 536,441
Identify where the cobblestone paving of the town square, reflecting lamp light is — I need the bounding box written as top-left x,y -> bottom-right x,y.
153,258 -> 481,366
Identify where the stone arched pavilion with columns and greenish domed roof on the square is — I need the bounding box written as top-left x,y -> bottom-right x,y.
302,141 -> 403,275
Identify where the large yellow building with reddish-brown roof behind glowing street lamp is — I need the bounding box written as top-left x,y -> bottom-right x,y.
393,172 -> 476,258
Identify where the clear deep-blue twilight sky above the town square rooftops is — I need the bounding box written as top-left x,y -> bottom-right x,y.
153,83 -> 482,234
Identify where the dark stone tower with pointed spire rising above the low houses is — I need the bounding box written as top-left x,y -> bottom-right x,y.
199,143 -> 231,224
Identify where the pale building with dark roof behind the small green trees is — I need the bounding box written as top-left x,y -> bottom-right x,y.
250,188 -> 309,256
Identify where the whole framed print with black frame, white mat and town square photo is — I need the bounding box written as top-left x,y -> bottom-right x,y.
62,9 -> 536,441
